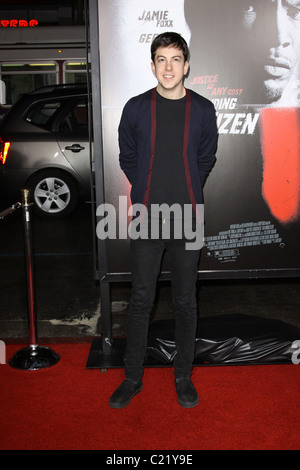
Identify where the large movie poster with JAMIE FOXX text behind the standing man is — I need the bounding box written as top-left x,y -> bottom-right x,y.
92,0 -> 300,277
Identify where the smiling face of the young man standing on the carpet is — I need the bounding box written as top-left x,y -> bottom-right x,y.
151,46 -> 189,99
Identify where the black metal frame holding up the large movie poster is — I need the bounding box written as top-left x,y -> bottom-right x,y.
86,0 -> 300,355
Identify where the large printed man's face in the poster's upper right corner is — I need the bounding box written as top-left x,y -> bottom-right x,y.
241,0 -> 300,102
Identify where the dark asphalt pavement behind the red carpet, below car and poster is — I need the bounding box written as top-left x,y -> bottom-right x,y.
0,196 -> 300,341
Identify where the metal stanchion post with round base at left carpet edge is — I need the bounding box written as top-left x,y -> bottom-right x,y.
8,189 -> 60,370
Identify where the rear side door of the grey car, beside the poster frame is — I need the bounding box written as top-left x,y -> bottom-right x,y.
57,97 -> 91,192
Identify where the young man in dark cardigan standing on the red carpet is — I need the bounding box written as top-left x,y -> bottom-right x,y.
109,32 -> 217,408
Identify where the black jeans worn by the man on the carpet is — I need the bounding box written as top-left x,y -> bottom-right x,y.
125,235 -> 200,382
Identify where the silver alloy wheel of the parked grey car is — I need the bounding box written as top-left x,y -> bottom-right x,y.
28,170 -> 78,218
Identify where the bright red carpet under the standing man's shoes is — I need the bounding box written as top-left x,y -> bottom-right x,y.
0,343 -> 300,451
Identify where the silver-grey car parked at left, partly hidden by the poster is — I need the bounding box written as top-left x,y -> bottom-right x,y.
0,85 -> 92,217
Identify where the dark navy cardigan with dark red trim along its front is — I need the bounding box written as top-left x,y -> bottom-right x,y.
119,89 -> 217,217
